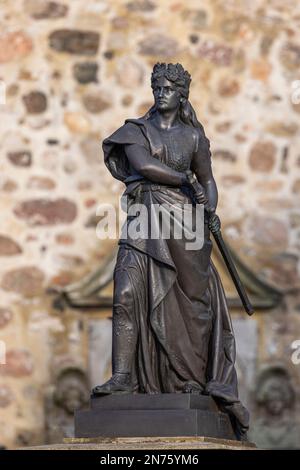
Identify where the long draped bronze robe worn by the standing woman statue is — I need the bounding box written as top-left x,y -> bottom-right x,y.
103,118 -> 249,439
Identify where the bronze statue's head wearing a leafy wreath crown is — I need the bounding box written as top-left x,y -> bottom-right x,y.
151,63 -> 191,111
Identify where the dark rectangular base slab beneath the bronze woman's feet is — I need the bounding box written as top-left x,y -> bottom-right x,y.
75,393 -> 236,440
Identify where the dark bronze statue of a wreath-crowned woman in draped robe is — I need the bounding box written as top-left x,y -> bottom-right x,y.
93,63 -> 249,439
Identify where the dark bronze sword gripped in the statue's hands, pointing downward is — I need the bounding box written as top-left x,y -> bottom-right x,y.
186,171 -> 254,315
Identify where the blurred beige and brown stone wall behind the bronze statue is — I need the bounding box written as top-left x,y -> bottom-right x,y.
0,0 -> 300,448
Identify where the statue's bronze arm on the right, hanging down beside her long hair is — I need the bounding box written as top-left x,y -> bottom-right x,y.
191,129 -> 218,211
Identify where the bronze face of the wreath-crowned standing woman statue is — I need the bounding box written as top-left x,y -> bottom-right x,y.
153,77 -> 180,112
